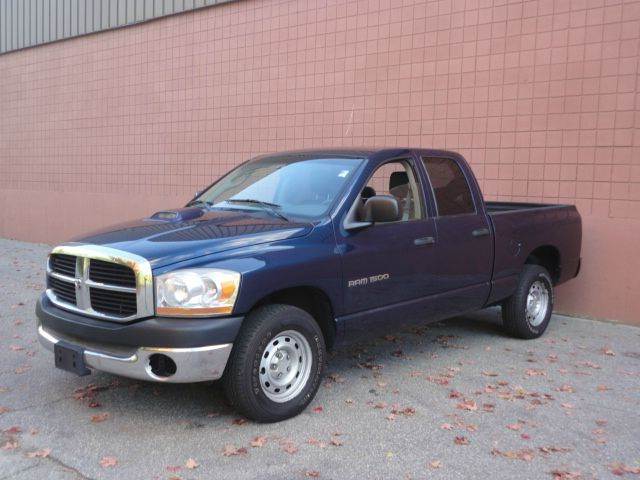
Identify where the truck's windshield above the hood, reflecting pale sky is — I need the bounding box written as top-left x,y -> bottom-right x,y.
192,155 -> 363,219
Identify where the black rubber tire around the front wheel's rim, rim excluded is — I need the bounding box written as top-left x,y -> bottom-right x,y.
222,305 -> 326,422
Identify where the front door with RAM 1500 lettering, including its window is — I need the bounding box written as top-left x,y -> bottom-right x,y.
338,159 -> 437,314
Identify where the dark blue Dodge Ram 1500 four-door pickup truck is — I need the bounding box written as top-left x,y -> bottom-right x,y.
36,148 -> 581,422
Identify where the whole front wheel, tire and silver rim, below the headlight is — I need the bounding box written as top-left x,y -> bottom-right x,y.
223,305 -> 326,422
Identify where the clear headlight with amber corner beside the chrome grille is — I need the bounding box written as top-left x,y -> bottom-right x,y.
155,268 -> 240,317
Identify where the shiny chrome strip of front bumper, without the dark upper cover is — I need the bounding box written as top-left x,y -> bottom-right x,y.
38,325 -> 233,383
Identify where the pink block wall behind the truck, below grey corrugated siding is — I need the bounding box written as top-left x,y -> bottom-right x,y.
0,0 -> 640,323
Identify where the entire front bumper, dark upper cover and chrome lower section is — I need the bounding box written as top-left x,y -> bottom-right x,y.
36,297 -> 242,383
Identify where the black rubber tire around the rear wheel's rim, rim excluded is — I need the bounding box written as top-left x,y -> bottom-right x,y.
502,265 -> 553,339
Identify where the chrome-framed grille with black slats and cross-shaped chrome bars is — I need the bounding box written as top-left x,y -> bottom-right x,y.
47,245 -> 154,322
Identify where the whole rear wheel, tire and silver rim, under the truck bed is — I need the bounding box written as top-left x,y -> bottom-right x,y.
502,265 -> 553,339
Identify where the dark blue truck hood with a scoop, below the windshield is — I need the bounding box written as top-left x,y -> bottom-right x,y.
72,208 -> 313,268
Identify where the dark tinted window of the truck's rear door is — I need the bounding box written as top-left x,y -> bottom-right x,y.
422,157 -> 476,217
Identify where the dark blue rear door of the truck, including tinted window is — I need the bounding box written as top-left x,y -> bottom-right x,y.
422,156 -> 493,315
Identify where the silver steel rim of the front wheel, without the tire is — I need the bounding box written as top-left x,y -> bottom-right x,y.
258,330 -> 313,403
